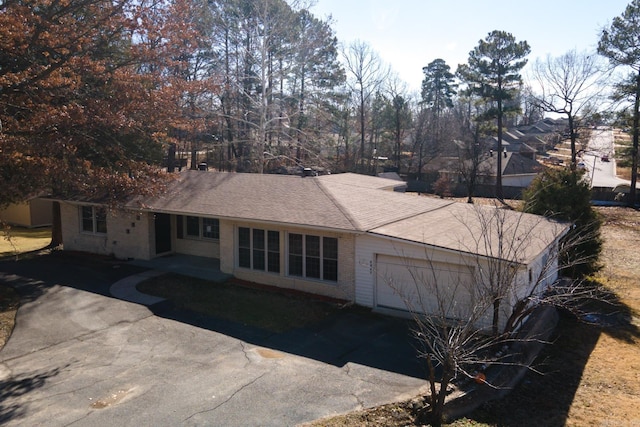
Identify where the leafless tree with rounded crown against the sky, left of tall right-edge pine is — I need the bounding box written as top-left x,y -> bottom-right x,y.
532,50 -> 608,170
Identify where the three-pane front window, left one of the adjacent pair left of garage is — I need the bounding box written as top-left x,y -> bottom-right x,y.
238,227 -> 280,273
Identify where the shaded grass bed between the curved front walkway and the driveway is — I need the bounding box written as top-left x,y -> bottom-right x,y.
137,274 -> 337,333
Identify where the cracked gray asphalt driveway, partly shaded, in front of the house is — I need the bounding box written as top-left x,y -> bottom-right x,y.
0,254 -> 425,426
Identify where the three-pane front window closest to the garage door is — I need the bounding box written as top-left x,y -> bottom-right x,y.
288,233 -> 338,282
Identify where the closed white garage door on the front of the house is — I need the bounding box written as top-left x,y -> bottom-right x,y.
376,255 -> 473,318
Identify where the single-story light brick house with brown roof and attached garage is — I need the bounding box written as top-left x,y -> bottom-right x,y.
61,171 -> 567,332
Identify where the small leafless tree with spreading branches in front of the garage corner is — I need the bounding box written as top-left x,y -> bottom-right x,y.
378,205 -> 598,425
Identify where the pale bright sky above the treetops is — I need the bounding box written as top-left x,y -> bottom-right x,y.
311,0 -> 631,91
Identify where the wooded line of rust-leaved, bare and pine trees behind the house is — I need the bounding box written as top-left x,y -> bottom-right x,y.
0,0 -> 640,207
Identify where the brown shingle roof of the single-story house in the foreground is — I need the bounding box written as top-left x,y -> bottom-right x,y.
128,171 -> 565,261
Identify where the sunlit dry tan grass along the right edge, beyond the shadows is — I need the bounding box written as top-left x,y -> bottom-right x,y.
568,208 -> 640,426
